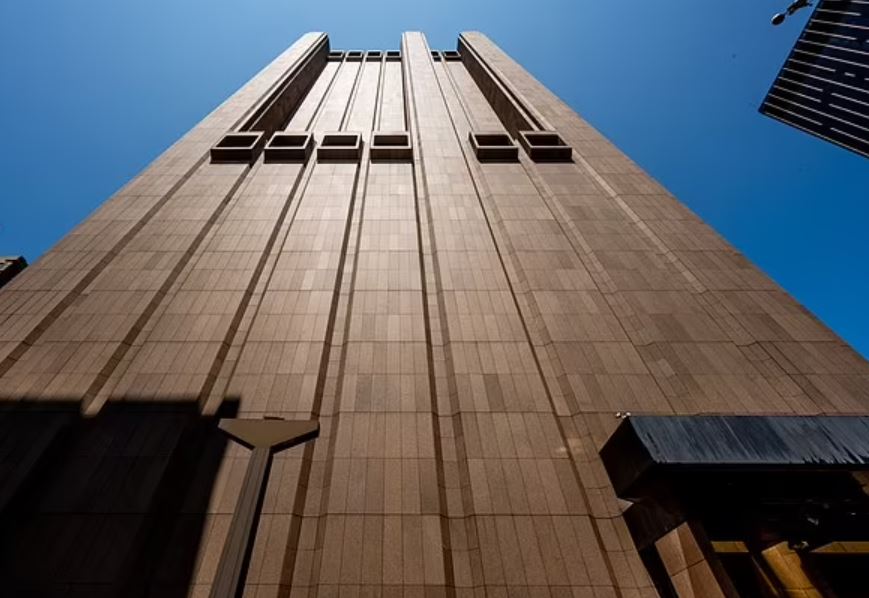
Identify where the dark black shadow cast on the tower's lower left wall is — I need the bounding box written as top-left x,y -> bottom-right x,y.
0,397 -> 238,597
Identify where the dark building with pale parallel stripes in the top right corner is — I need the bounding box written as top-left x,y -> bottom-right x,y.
760,0 -> 869,157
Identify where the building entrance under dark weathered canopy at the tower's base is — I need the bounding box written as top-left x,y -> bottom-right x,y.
601,416 -> 869,598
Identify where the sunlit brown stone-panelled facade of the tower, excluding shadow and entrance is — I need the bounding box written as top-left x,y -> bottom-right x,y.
0,33 -> 869,598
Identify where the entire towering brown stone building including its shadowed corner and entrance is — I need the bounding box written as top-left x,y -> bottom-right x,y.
0,33 -> 869,598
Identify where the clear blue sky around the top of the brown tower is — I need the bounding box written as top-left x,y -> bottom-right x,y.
0,0 -> 869,355
